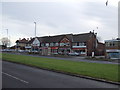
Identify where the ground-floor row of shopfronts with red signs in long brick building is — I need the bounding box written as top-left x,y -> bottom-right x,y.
27,47 -> 87,56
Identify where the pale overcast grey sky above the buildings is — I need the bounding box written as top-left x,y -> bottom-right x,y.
0,0 -> 119,46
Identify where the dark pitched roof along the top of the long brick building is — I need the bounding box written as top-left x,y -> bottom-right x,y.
16,32 -> 96,44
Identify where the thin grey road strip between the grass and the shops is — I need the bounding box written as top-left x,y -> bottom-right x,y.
3,53 -> 120,64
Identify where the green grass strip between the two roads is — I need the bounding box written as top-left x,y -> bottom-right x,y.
2,53 -> 120,82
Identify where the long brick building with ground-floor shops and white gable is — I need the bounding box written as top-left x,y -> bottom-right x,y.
25,31 -> 105,56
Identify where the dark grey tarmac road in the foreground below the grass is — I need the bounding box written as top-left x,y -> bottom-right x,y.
2,61 -> 118,88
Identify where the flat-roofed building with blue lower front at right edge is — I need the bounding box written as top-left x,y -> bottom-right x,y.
105,38 -> 120,59
